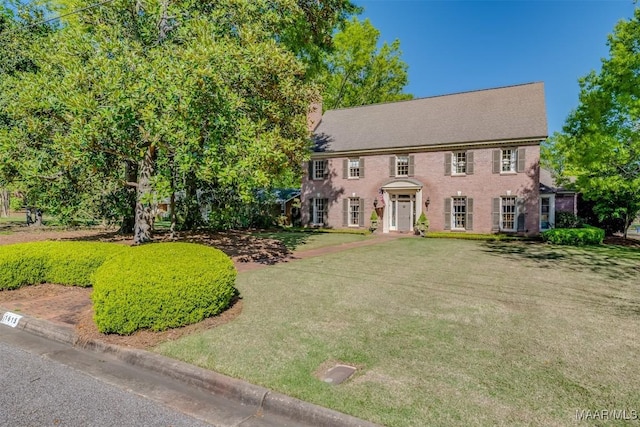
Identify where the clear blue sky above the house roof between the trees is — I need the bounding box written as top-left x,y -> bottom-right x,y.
353,0 -> 640,135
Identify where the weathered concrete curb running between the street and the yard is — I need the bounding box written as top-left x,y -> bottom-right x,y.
0,307 -> 380,427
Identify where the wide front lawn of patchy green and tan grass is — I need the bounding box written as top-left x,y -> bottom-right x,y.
156,238 -> 640,426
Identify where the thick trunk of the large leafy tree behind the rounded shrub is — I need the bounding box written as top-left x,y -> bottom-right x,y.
133,145 -> 156,245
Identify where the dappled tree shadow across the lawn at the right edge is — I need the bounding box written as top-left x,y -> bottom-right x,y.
483,242 -> 640,280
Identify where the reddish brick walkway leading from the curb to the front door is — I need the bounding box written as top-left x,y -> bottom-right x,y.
0,234 -> 408,326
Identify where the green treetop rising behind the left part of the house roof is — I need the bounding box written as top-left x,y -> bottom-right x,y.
321,17 -> 412,110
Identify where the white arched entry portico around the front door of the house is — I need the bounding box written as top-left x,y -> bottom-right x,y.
382,178 -> 422,233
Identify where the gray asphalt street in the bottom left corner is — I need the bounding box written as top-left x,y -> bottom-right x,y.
0,324 -> 308,427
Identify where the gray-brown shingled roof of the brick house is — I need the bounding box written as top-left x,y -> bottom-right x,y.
314,83 -> 547,152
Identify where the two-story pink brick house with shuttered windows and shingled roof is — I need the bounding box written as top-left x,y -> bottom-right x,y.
301,83 -> 547,234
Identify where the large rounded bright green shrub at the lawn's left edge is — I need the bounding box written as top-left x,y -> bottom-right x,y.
91,243 -> 236,335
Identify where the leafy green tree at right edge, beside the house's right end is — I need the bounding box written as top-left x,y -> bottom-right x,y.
550,8 -> 640,237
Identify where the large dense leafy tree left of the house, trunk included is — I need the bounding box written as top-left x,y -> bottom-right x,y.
0,0 -> 354,243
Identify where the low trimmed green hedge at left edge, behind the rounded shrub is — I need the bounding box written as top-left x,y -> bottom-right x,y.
0,242 -> 128,290
